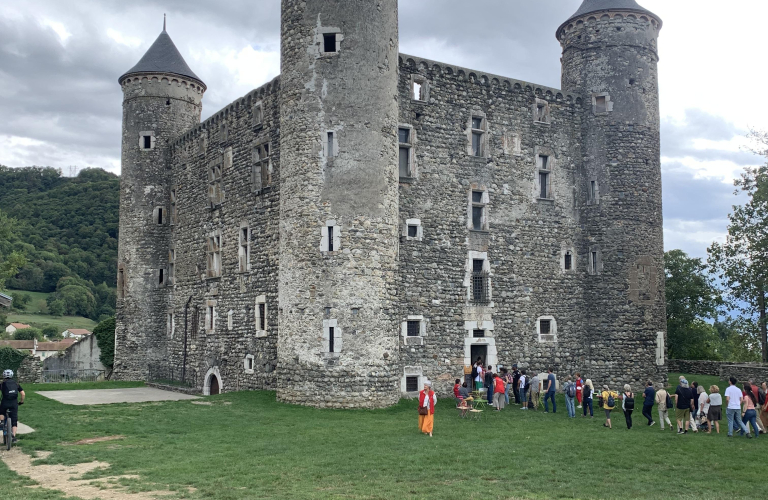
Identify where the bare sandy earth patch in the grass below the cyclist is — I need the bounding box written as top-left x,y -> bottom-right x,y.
2,448 -> 182,500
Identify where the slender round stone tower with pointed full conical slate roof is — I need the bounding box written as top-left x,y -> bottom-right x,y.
115,26 -> 206,379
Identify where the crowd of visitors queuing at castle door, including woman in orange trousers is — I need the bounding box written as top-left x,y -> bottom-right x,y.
419,358 -> 768,439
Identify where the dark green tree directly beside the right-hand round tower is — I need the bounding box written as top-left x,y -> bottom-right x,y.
664,250 -> 723,359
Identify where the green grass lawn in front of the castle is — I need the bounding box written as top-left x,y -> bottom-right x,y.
0,374 -> 768,500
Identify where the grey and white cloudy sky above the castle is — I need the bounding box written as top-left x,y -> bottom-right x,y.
0,0 -> 768,256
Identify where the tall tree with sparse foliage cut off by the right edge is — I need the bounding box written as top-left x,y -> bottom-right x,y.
707,139 -> 768,362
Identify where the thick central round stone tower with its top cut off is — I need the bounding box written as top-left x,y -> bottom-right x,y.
277,0 -> 399,408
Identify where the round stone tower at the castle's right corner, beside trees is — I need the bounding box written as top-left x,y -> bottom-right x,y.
557,0 -> 666,384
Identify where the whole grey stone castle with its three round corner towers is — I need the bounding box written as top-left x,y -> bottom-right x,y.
114,0 -> 667,408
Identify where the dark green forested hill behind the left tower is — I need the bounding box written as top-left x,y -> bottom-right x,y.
0,166 -> 120,292
